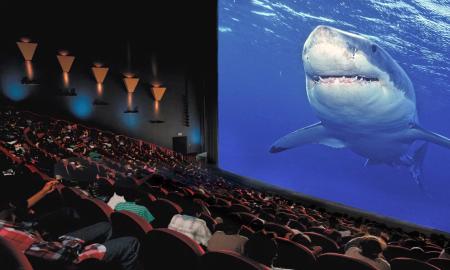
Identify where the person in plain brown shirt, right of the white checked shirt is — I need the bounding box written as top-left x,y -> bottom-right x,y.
208,222 -> 248,254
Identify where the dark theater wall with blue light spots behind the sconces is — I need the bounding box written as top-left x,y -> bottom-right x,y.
0,3 -> 217,153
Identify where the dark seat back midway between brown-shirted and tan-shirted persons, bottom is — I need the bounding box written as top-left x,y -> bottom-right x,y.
274,237 -> 317,269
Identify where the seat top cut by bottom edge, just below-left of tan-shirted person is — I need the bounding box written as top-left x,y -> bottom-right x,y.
317,253 -> 377,270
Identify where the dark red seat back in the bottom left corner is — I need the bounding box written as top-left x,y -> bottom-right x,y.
0,237 -> 33,270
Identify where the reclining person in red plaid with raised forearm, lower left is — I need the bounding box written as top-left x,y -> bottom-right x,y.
0,181 -> 139,270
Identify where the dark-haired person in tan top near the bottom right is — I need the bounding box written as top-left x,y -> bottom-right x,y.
345,236 -> 391,270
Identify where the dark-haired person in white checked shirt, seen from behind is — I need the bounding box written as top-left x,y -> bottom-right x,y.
168,204 -> 211,247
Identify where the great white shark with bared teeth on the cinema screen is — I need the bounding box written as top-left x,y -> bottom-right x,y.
270,25 -> 450,187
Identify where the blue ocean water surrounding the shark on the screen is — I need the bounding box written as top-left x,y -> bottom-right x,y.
218,0 -> 450,232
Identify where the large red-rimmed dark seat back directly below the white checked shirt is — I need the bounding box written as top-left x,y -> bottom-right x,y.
145,229 -> 205,270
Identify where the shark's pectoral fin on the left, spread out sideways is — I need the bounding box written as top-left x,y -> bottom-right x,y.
270,122 -> 345,153
